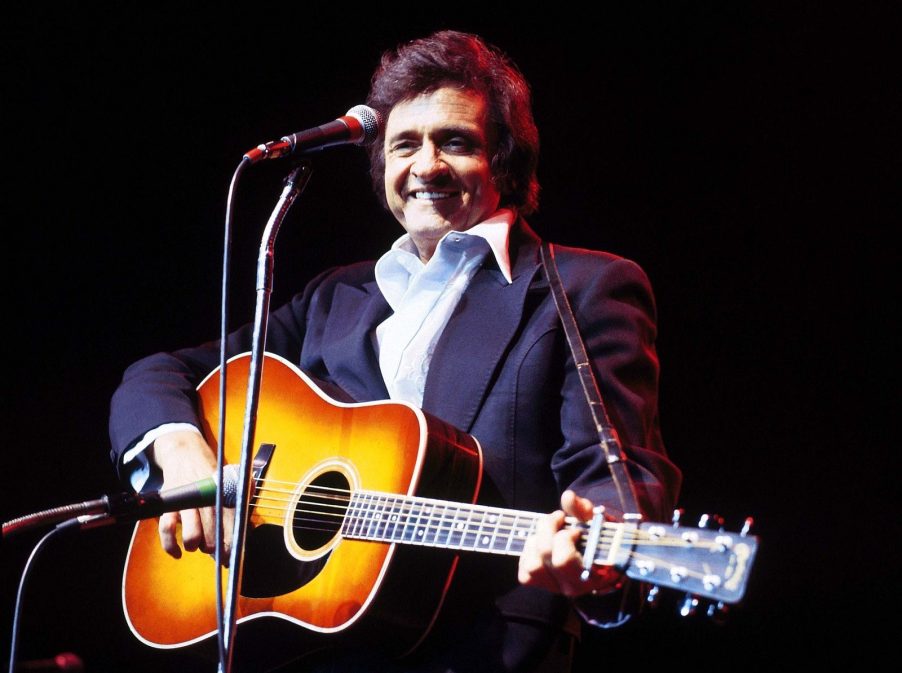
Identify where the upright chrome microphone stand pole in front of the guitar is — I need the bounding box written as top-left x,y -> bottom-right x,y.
219,162 -> 311,673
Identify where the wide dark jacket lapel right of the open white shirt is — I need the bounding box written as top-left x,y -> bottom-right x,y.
423,223 -> 540,432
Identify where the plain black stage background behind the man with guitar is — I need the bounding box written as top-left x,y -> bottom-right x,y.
2,2 -> 899,672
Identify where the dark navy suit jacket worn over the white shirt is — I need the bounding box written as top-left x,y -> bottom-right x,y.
110,222 -> 680,668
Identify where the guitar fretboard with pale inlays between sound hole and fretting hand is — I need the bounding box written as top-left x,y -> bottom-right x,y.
341,491 -> 540,556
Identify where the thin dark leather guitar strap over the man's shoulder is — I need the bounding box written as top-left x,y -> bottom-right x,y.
540,241 -> 641,522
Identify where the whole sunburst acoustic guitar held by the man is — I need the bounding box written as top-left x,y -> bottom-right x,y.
122,354 -> 757,651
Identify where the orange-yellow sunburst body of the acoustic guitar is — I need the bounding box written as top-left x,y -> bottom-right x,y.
123,354 -> 481,654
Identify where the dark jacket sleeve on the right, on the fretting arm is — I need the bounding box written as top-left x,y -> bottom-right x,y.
552,255 -> 681,520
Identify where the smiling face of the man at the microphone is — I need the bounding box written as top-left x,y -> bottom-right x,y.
384,87 -> 501,260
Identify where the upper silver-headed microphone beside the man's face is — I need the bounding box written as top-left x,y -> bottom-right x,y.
244,105 -> 382,163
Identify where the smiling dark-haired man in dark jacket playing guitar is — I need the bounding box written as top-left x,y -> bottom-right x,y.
111,31 -> 680,673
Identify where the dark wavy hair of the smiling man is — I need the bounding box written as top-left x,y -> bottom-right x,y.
367,30 -> 539,215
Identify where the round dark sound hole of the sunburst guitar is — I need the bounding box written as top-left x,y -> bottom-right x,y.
292,471 -> 351,551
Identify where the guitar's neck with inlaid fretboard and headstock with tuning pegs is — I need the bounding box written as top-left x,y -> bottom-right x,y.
341,484 -> 757,603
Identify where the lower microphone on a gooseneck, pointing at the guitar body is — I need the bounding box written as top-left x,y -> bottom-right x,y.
3,465 -> 238,538
